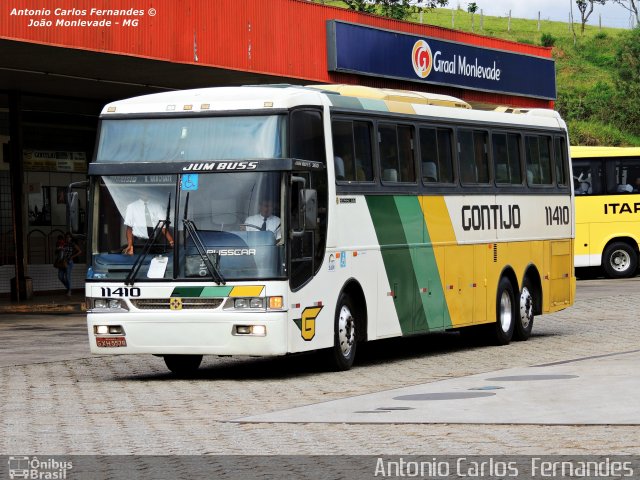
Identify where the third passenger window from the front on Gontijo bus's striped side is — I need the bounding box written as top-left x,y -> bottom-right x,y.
420,128 -> 453,183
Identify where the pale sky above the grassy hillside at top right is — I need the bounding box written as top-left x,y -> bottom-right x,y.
449,0 -> 631,28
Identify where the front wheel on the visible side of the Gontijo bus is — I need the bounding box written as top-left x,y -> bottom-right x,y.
331,293 -> 360,371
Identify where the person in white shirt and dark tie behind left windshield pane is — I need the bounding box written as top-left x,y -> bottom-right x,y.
122,195 -> 173,255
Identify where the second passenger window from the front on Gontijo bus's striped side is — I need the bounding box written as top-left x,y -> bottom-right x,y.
378,124 -> 416,182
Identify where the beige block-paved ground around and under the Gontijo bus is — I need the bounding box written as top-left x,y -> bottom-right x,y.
0,278 -> 640,455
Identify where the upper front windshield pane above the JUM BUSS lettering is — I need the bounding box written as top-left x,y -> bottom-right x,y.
96,115 -> 285,162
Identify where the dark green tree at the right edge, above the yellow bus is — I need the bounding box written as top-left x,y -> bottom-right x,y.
613,27 -> 640,135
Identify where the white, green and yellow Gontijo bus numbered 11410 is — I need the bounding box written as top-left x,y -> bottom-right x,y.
86,85 -> 575,373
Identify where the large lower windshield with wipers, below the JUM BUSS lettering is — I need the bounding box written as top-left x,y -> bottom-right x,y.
89,172 -> 286,281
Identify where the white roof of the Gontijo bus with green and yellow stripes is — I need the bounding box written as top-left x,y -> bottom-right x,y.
102,85 -> 566,129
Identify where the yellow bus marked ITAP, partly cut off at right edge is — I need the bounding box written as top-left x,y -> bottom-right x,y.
571,146 -> 640,278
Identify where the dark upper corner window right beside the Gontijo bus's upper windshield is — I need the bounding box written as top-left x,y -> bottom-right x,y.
289,110 -> 326,163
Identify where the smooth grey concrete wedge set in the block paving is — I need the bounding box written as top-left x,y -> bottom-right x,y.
237,350 -> 640,425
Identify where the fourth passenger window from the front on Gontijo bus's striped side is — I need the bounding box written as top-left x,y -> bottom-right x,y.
458,129 -> 490,184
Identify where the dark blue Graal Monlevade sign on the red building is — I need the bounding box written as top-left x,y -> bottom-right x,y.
327,20 -> 556,100
